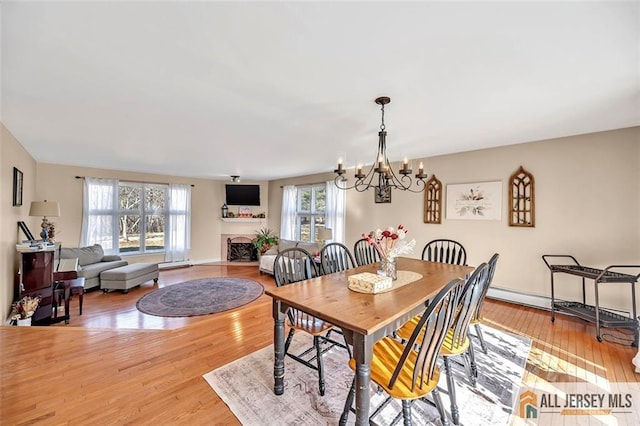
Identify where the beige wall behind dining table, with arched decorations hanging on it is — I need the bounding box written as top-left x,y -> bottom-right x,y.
269,127 -> 640,311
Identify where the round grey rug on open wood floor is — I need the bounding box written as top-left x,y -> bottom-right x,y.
136,277 -> 264,317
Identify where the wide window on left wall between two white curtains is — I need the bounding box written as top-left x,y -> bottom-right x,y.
118,182 -> 168,253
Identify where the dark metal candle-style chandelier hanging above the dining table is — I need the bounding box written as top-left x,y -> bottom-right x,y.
334,96 -> 427,200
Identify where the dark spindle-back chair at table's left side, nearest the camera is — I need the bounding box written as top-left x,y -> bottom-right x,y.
273,247 -> 351,395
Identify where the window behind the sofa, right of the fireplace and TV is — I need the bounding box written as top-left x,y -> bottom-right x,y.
296,184 -> 327,242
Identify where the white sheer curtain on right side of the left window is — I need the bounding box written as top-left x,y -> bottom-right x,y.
164,184 -> 191,262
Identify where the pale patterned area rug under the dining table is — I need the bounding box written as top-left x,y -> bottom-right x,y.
203,326 -> 531,426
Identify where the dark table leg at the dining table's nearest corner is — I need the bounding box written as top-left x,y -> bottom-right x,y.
353,333 -> 373,425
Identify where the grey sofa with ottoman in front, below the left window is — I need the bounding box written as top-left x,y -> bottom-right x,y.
60,244 -> 129,290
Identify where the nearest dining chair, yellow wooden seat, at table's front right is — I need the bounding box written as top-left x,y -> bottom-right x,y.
340,278 -> 464,425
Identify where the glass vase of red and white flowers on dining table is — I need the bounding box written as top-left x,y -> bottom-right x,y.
362,225 -> 416,280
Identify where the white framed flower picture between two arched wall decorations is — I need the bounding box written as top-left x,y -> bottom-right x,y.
447,181 -> 502,220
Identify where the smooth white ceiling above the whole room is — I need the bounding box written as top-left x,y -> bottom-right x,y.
0,1 -> 640,180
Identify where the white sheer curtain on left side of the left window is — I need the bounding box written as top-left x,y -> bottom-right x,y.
80,177 -> 119,254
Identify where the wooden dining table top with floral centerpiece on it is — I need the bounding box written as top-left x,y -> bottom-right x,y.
265,257 -> 473,335
